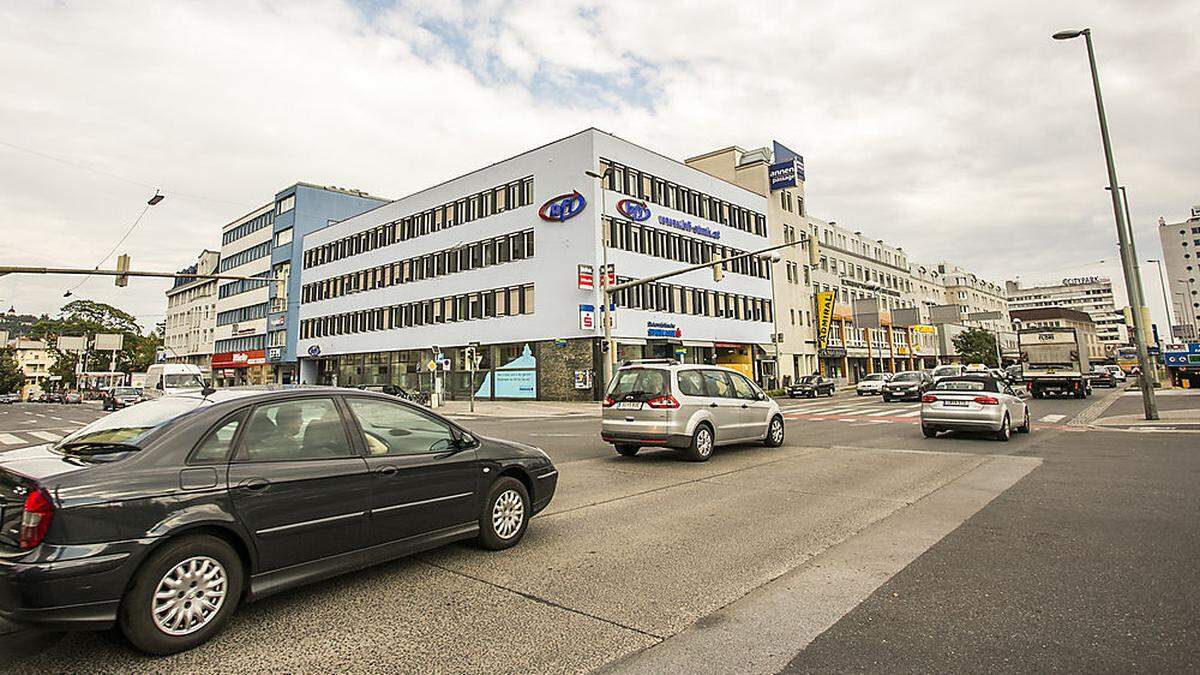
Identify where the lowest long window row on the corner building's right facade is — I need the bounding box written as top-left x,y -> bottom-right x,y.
613,277 -> 774,322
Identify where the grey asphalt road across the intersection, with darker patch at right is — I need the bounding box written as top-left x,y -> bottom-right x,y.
0,392 -> 1200,673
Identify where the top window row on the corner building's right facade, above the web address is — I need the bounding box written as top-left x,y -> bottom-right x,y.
600,159 -> 767,237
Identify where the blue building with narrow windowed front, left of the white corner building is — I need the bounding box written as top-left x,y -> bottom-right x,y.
265,183 -> 389,384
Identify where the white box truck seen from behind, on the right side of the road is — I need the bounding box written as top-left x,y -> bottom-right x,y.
1018,327 -> 1091,399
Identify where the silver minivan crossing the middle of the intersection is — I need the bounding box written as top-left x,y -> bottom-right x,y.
600,359 -> 784,461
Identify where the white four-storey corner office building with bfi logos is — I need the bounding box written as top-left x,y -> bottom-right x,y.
298,129 -> 775,400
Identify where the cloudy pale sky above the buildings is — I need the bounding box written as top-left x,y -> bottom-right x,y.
0,0 -> 1200,333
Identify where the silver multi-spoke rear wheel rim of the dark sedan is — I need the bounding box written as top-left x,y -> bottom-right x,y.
150,556 -> 228,638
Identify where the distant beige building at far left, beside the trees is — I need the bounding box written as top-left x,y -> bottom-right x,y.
162,250 -> 221,371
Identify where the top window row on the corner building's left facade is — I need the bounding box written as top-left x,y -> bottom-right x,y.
304,175 -> 533,269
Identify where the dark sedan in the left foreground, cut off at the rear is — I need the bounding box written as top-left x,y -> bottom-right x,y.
0,388 -> 558,655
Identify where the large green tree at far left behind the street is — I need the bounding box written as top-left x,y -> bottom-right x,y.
29,300 -> 162,387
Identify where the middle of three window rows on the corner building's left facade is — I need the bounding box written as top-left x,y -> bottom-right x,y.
300,228 -> 533,303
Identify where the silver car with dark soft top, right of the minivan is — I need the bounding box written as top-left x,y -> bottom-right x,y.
920,375 -> 1030,441
